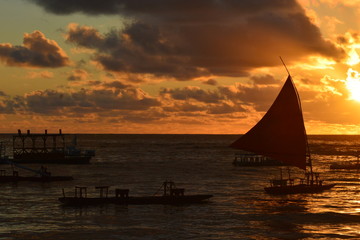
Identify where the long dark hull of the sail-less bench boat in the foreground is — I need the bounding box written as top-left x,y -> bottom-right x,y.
59,194 -> 212,206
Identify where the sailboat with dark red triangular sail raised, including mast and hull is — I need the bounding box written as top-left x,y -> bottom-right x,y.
230,59 -> 335,194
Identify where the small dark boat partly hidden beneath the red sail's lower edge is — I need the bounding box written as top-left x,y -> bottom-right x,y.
233,153 -> 285,167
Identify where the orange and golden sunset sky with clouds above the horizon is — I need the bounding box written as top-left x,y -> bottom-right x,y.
0,0 -> 360,134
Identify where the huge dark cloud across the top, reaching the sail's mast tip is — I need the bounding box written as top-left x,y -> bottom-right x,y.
29,0 -> 344,80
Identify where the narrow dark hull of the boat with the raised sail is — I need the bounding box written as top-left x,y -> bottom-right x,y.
264,184 -> 335,195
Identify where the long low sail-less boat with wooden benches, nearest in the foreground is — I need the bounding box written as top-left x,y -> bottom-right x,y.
59,181 -> 212,206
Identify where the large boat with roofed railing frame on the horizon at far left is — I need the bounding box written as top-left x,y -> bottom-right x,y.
12,129 -> 95,164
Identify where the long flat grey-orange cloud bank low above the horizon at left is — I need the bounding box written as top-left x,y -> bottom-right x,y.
23,85 -> 160,115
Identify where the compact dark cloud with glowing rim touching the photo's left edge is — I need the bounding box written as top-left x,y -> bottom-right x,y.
0,31 -> 69,68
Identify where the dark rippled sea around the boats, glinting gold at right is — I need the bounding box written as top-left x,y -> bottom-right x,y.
0,134 -> 360,240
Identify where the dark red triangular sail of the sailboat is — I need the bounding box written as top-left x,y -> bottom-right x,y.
231,75 -> 307,170
